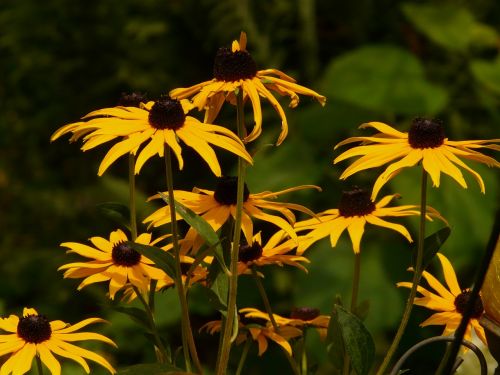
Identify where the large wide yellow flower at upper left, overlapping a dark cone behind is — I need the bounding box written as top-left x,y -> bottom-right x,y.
51,97 -> 252,176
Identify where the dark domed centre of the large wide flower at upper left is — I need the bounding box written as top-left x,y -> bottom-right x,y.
149,96 -> 186,130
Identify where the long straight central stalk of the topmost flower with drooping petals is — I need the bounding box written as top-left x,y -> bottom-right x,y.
216,90 -> 246,375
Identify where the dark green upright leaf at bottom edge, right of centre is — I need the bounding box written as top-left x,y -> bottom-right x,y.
327,305 -> 375,375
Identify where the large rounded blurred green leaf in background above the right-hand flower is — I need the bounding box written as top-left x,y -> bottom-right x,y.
323,45 -> 448,115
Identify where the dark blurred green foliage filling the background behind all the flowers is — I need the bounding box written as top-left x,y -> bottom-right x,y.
0,0 -> 500,374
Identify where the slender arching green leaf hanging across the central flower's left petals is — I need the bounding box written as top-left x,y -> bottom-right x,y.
159,192 -> 229,274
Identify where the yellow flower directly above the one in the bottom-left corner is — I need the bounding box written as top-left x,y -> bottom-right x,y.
59,229 -> 165,299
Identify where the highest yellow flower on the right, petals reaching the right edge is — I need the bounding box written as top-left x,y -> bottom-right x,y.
333,117 -> 500,199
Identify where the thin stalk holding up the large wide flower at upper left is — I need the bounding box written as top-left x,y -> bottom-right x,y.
165,144 -> 203,374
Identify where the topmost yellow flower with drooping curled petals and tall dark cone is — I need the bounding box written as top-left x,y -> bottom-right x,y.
170,32 -> 326,145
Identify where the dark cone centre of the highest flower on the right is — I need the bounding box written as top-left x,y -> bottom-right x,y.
408,117 -> 445,148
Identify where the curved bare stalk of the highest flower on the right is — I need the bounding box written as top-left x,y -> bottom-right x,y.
377,167 -> 427,375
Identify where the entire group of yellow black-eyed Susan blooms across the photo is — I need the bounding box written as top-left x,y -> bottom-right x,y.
0,33 -> 500,375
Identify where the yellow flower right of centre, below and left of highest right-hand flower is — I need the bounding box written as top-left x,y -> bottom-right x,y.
295,188 -> 444,255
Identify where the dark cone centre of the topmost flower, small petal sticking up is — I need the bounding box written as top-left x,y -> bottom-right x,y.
214,47 -> 257,82
